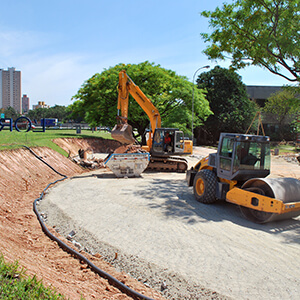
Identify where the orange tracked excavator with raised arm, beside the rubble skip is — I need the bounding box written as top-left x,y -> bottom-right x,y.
111,70 -> 193,172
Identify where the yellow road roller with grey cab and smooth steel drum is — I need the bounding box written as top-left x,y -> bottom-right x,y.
186,133 -> 300,223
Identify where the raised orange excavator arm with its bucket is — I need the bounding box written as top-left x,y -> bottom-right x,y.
111,70 -> 161,148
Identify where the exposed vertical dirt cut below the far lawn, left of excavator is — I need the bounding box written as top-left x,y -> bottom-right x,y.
53,138 -> 121,156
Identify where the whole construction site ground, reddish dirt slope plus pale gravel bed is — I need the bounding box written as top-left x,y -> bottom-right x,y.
0,140 -> 300,299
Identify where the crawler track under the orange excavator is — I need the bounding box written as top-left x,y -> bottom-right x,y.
147,156 -> 188,173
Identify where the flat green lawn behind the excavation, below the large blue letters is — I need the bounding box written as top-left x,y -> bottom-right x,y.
0,129 -> 111,156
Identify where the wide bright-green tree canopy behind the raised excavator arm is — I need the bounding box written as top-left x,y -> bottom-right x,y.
72,62 -> 211,142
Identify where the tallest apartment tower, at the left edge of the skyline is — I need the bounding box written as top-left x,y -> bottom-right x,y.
0,68 -> 22,113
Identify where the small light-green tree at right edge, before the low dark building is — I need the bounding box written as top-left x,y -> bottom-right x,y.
263,88 -> 300,140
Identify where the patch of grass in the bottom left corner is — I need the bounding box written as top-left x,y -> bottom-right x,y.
0,255 -> 65,300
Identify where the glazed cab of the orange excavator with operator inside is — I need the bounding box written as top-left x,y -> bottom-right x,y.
150,128 -> 184,156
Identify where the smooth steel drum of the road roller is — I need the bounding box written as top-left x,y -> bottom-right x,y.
240,178 -> 300,223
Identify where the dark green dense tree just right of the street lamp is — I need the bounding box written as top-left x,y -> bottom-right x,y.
197,67 -> 256,142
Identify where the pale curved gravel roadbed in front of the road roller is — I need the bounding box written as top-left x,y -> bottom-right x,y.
39,151 -> 300,299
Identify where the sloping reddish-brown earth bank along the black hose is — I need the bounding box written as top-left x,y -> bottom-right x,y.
0,145 -> 163,300
